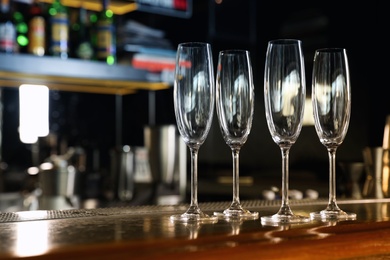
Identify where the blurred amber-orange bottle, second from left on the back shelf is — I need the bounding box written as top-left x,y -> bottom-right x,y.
27,0 -> 46,56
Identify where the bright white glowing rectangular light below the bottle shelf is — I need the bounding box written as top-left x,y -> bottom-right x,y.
19,84 -> 49,143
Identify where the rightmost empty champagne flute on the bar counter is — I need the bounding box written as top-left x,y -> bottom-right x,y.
310,48 -> 356,220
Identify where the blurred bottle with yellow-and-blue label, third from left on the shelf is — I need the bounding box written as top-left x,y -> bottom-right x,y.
49,0 -> 69,59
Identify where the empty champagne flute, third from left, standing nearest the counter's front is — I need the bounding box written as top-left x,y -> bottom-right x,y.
261,39 -> 310,225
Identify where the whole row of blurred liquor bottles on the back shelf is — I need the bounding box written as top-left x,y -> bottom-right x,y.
0,0 -> 116,65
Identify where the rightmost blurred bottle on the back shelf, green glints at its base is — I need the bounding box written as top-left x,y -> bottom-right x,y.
96,0 -> 116,65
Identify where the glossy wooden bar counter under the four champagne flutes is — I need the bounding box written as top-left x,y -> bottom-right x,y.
0,199 -> 390,260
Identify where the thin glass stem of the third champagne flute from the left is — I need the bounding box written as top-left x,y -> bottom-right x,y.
279,147 -> 293,215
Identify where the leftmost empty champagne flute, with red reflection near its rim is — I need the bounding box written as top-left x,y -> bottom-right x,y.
171,42 -> 218,222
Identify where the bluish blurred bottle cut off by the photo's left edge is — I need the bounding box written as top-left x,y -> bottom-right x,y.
0,0 -> 16,53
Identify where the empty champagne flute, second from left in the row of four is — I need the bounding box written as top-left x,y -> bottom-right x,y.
214,50 -> 259,220
